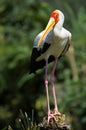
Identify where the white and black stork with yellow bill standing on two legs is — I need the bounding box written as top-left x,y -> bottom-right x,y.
30,10 -> 71,122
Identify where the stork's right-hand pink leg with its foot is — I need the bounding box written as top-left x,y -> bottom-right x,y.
50,58 -> 60,115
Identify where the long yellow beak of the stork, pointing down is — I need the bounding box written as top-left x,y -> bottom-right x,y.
38,18 -> 55,46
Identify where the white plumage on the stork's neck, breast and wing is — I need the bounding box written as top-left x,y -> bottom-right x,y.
33,10 -> 71,61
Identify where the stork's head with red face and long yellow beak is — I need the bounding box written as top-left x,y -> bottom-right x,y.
38,10 -> 63,46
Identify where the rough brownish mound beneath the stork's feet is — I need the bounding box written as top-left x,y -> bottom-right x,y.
39,114 -> 70,130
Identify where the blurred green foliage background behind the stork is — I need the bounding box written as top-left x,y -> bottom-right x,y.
0,0 -> 86,130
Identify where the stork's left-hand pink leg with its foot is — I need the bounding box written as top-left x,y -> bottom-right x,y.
45,58 -> 54,123
